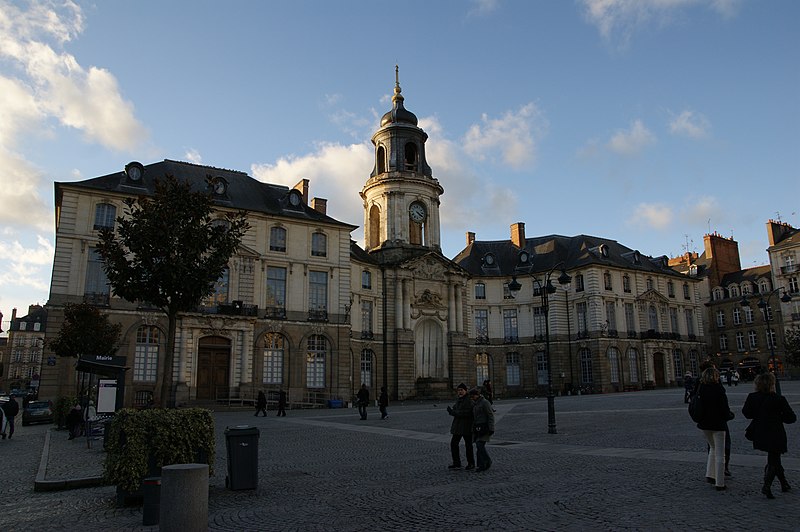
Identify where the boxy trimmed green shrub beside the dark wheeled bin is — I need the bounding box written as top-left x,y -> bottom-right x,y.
103,408 -> 215,492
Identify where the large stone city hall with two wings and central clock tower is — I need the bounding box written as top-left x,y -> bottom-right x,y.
41,77 -> 705,406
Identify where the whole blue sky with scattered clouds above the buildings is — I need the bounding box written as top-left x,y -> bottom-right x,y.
0,0 -> 800,329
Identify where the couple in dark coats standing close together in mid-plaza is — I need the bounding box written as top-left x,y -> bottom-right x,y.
447,382 -> 494,471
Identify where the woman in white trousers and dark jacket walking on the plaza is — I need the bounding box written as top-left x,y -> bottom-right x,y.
697,367 -> 733,491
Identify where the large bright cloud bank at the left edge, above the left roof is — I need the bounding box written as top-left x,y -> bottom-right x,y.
0,0 -> 147,229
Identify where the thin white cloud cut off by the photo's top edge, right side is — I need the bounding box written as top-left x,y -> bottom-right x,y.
580,0 -> 741,44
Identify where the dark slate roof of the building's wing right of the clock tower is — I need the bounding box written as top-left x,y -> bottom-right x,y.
453,235 -> 684,278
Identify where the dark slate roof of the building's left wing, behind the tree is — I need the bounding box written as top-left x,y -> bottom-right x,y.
55,159 -> 357,230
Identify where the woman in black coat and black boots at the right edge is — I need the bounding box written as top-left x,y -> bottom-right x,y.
742,373 -> 797,499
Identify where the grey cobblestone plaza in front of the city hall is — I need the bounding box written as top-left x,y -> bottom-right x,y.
0,382 -> 800,531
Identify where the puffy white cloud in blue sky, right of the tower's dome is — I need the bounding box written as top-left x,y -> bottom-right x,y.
463,103 -> 549,169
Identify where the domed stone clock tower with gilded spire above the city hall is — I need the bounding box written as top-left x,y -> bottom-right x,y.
361,67 -> 444,255
